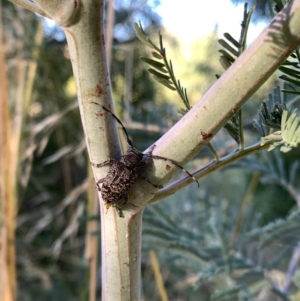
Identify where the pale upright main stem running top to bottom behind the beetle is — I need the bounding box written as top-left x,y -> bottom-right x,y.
39,0 -> 142,301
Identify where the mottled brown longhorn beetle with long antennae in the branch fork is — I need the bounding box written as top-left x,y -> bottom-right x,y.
91,102 -> 199,217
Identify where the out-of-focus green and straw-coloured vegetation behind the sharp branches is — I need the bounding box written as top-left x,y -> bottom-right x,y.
1,0 -> 300,301
